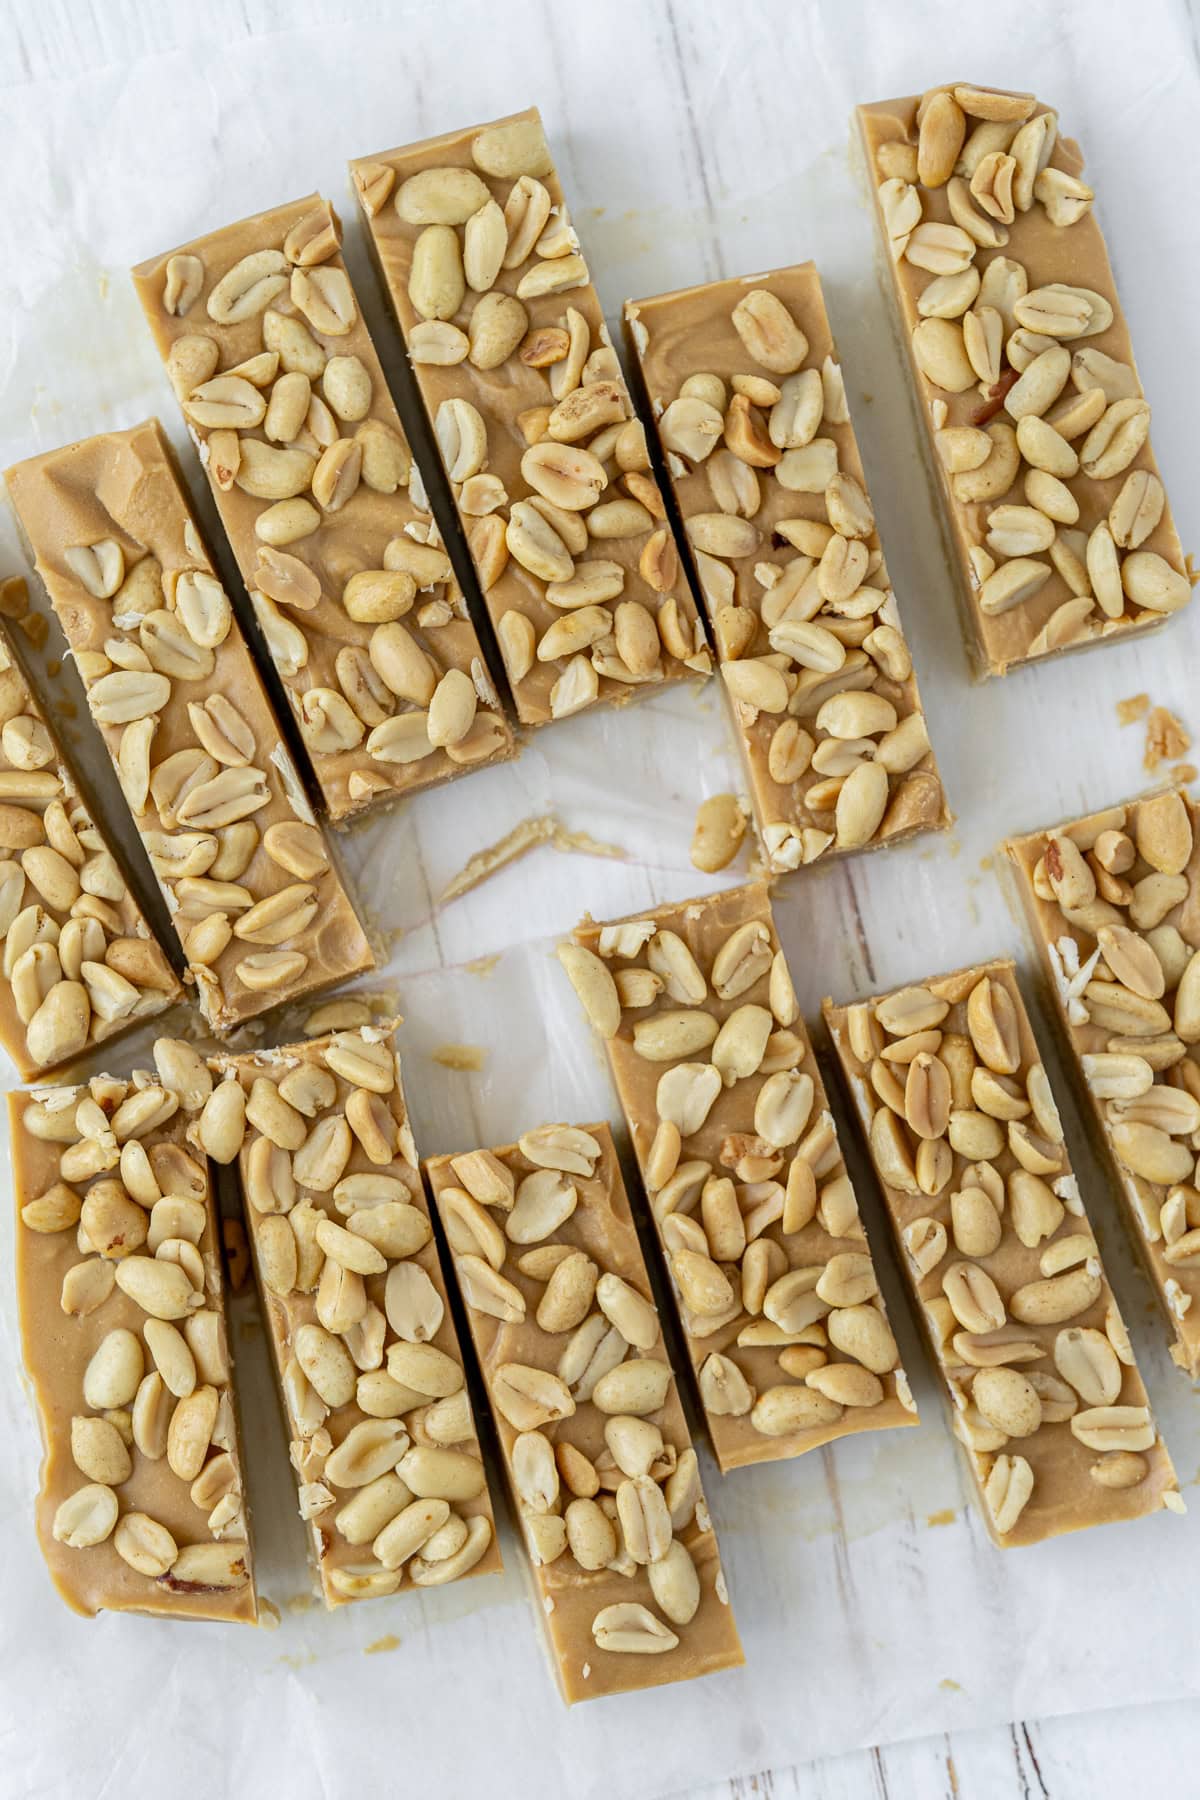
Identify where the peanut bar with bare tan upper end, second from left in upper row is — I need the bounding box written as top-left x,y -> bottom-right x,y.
7,419 -> 374,1031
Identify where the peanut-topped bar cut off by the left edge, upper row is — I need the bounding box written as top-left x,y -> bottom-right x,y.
0,578 -> 184,1082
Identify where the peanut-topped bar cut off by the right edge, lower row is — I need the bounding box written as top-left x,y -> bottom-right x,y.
1004,794 -> 1200,1377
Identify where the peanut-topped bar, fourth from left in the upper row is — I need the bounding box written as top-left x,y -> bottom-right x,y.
351,108 -> 711,725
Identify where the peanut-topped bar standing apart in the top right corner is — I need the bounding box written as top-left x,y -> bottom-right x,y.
858,85 -> 1191,675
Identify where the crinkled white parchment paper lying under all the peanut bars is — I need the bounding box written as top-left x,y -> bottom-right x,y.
0,0 -> 1200,1800
